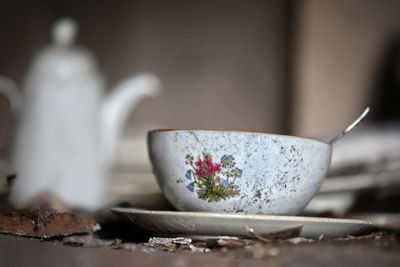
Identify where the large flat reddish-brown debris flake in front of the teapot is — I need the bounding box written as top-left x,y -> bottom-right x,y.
0,208 -> 100,239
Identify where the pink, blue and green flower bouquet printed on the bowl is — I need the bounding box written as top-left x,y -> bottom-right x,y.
185,152 -> 242,202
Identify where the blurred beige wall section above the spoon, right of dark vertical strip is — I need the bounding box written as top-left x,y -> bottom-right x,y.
293,0 -> 400,136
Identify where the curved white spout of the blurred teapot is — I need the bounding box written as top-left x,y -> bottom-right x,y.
100,73 -> 161,166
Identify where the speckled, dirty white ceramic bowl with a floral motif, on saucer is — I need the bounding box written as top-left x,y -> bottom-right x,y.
148,130 -> 331,215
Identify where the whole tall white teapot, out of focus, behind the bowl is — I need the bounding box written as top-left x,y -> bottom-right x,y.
0,19 -> 160,210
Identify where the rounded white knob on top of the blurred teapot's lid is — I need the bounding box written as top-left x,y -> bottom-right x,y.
52,18 -> 78,46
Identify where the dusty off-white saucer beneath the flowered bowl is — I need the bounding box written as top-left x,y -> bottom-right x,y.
112,208 -> 372,238
